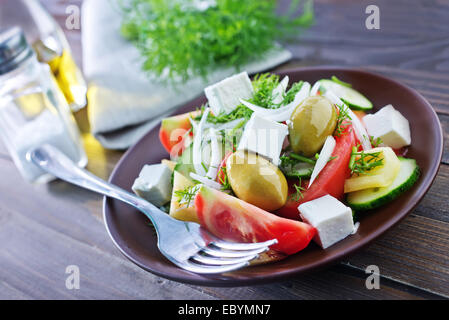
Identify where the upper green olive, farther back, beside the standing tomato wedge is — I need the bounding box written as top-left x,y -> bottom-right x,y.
288,96 -> 337,157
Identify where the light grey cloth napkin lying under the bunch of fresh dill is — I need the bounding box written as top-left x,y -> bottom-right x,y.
82,0 -> 292,149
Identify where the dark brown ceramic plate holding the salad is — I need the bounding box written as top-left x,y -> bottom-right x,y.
104,67 -> 443,286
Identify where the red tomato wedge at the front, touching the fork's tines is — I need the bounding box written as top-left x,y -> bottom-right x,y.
195,186 -> 316,254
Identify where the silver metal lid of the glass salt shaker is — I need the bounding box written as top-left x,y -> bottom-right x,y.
0,27 -> 33,75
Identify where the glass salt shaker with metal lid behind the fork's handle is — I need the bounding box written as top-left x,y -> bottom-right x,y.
0,27 -> 87,183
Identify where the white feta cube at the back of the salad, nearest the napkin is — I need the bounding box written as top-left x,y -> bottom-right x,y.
204,72 -> 254,115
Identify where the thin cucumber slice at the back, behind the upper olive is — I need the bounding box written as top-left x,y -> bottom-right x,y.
320,79 -> 373,110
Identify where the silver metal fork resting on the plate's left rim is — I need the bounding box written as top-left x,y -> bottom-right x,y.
27,145 -> 277,274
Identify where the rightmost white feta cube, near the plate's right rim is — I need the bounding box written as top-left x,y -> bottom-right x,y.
363,104 -> 412,149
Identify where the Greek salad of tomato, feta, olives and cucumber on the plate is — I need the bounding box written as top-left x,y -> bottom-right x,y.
132,72 -> 420,261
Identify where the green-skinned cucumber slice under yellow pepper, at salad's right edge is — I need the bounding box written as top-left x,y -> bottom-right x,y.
347,157 -> 420,211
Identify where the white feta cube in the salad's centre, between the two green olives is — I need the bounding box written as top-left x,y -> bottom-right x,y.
237,113 -> 288,166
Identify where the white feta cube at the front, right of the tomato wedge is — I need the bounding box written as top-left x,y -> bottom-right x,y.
298,195 -> 354,249
